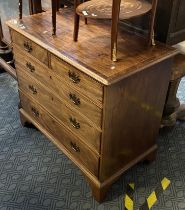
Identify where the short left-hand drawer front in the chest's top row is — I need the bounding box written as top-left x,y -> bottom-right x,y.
11,30 -> 48,66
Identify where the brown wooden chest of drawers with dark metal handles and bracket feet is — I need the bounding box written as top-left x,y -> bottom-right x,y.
7,9 -> 177,201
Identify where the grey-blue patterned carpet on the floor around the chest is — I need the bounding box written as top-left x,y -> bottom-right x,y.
0,73 -> 185,210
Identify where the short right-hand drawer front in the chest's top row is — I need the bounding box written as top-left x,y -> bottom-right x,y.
51,55 -> 103,103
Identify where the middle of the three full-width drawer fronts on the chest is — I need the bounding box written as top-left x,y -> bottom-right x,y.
18,70 -> 101,152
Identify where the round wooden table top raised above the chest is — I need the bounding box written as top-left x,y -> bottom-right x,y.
76,0 -> 152,19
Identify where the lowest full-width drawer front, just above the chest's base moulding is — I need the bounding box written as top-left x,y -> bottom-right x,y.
20,92 -> 99,177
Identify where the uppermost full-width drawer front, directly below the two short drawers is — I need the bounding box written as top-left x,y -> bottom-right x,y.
14,50 -> 102,128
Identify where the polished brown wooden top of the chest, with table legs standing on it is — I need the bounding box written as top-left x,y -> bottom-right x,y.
7,8 -> 177,85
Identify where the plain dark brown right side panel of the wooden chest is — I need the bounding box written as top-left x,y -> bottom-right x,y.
100,59 -> 172,181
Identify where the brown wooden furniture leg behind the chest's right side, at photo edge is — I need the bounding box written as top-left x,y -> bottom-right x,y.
161,54 -> 185,127
